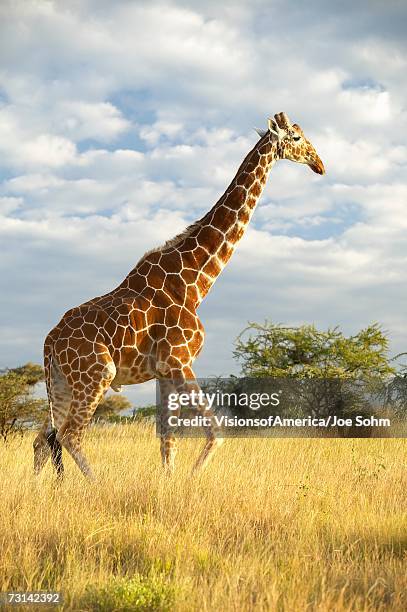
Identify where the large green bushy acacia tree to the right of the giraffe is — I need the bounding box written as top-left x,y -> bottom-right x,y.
234,321 -> 395,416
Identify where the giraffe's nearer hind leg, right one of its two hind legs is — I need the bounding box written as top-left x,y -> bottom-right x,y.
56,354 -> 116,479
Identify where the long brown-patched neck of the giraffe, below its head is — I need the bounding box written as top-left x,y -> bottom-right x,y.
127,132 -> 277,307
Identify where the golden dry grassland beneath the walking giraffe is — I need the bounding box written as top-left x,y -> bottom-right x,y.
0,424 -> 407,612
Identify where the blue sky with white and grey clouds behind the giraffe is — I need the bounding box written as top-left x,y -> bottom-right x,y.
0,0 -> 407,403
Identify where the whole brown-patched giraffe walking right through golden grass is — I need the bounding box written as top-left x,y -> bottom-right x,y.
34,112 -> 325,477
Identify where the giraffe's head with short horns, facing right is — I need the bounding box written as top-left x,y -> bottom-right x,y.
268,113 -> 325,174
